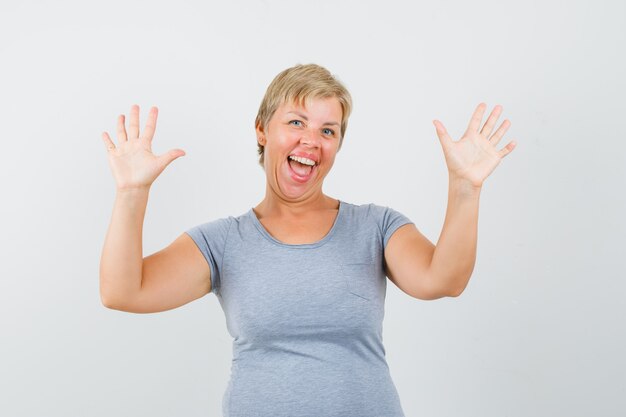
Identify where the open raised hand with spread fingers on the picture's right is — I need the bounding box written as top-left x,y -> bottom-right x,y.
433,103 -> 517,188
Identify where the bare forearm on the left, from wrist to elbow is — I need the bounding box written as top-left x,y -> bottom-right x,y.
100,188 -> 149,307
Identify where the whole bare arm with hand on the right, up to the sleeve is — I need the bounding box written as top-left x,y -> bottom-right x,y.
385,103 -> 516,300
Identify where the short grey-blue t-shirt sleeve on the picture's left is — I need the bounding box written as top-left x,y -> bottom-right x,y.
185,217 -> 235,294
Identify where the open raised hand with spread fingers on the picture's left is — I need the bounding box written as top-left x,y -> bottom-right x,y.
102,104 -> 185,190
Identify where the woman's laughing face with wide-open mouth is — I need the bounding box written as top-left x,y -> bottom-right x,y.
256,97 -> 342,201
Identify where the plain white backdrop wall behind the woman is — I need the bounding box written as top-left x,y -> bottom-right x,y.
0,0 -> 626,417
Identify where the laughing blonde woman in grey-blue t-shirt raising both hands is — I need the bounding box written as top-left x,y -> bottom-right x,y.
100,64 -> 514,417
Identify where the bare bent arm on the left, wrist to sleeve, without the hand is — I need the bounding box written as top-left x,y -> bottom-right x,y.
100,184 -> 211,313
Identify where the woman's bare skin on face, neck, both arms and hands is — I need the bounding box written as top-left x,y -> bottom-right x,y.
100,98 -> 516,313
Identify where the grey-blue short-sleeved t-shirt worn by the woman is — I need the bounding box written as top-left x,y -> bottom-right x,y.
187,201 -> 412,417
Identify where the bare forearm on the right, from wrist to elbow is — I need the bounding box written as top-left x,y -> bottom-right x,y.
430,178 -> 481,295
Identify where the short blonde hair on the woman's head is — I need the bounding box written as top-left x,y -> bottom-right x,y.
254,64 -> 352,166
